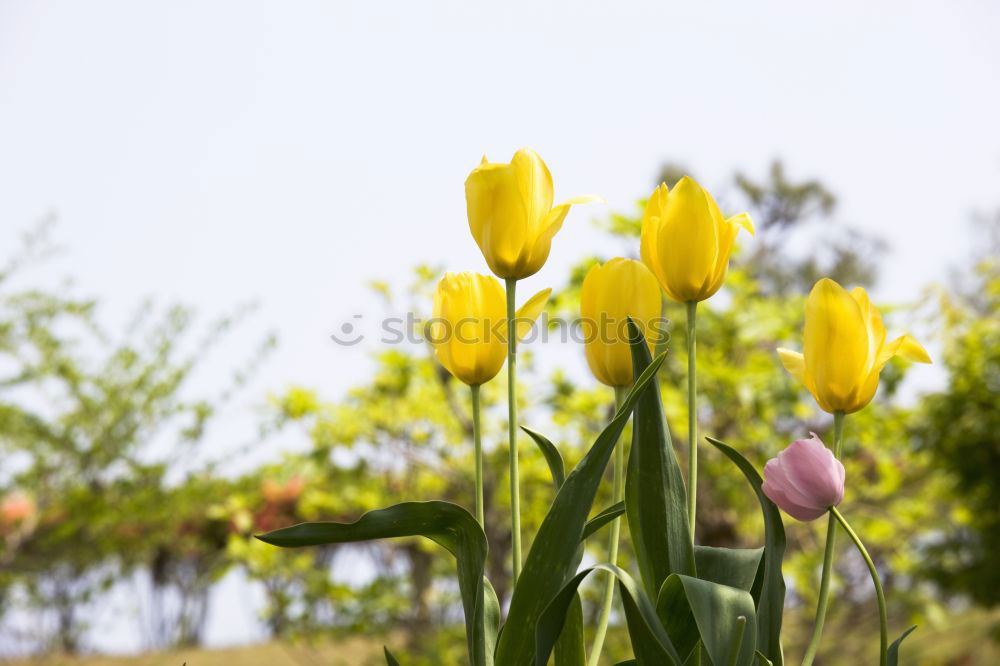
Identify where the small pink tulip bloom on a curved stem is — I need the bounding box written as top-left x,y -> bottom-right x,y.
763,433 -> 844,521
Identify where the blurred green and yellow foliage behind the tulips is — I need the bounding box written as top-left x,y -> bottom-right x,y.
0,163 -> 1000,664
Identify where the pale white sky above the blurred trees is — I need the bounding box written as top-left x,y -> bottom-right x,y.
0,0 -> 1000,648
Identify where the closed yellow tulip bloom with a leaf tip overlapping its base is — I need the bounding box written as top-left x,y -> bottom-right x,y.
580,258 -> 661,386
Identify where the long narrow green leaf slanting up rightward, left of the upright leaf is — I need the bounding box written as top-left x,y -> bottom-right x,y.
496,356 -> 663,666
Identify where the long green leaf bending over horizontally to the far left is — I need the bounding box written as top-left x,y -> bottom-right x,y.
257,501 -> 499,666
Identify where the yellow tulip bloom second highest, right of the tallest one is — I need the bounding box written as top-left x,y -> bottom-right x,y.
641,176 -> 754,303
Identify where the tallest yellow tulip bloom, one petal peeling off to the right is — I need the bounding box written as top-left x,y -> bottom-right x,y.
465,148 -> 601,280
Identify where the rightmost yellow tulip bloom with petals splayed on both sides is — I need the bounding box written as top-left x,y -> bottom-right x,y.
778,278 -> 931,414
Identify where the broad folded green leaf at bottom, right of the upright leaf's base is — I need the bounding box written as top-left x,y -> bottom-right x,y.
656,574 -> 757,666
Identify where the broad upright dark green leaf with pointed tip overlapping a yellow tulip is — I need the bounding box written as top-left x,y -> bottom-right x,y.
625,320 -> 696,596
